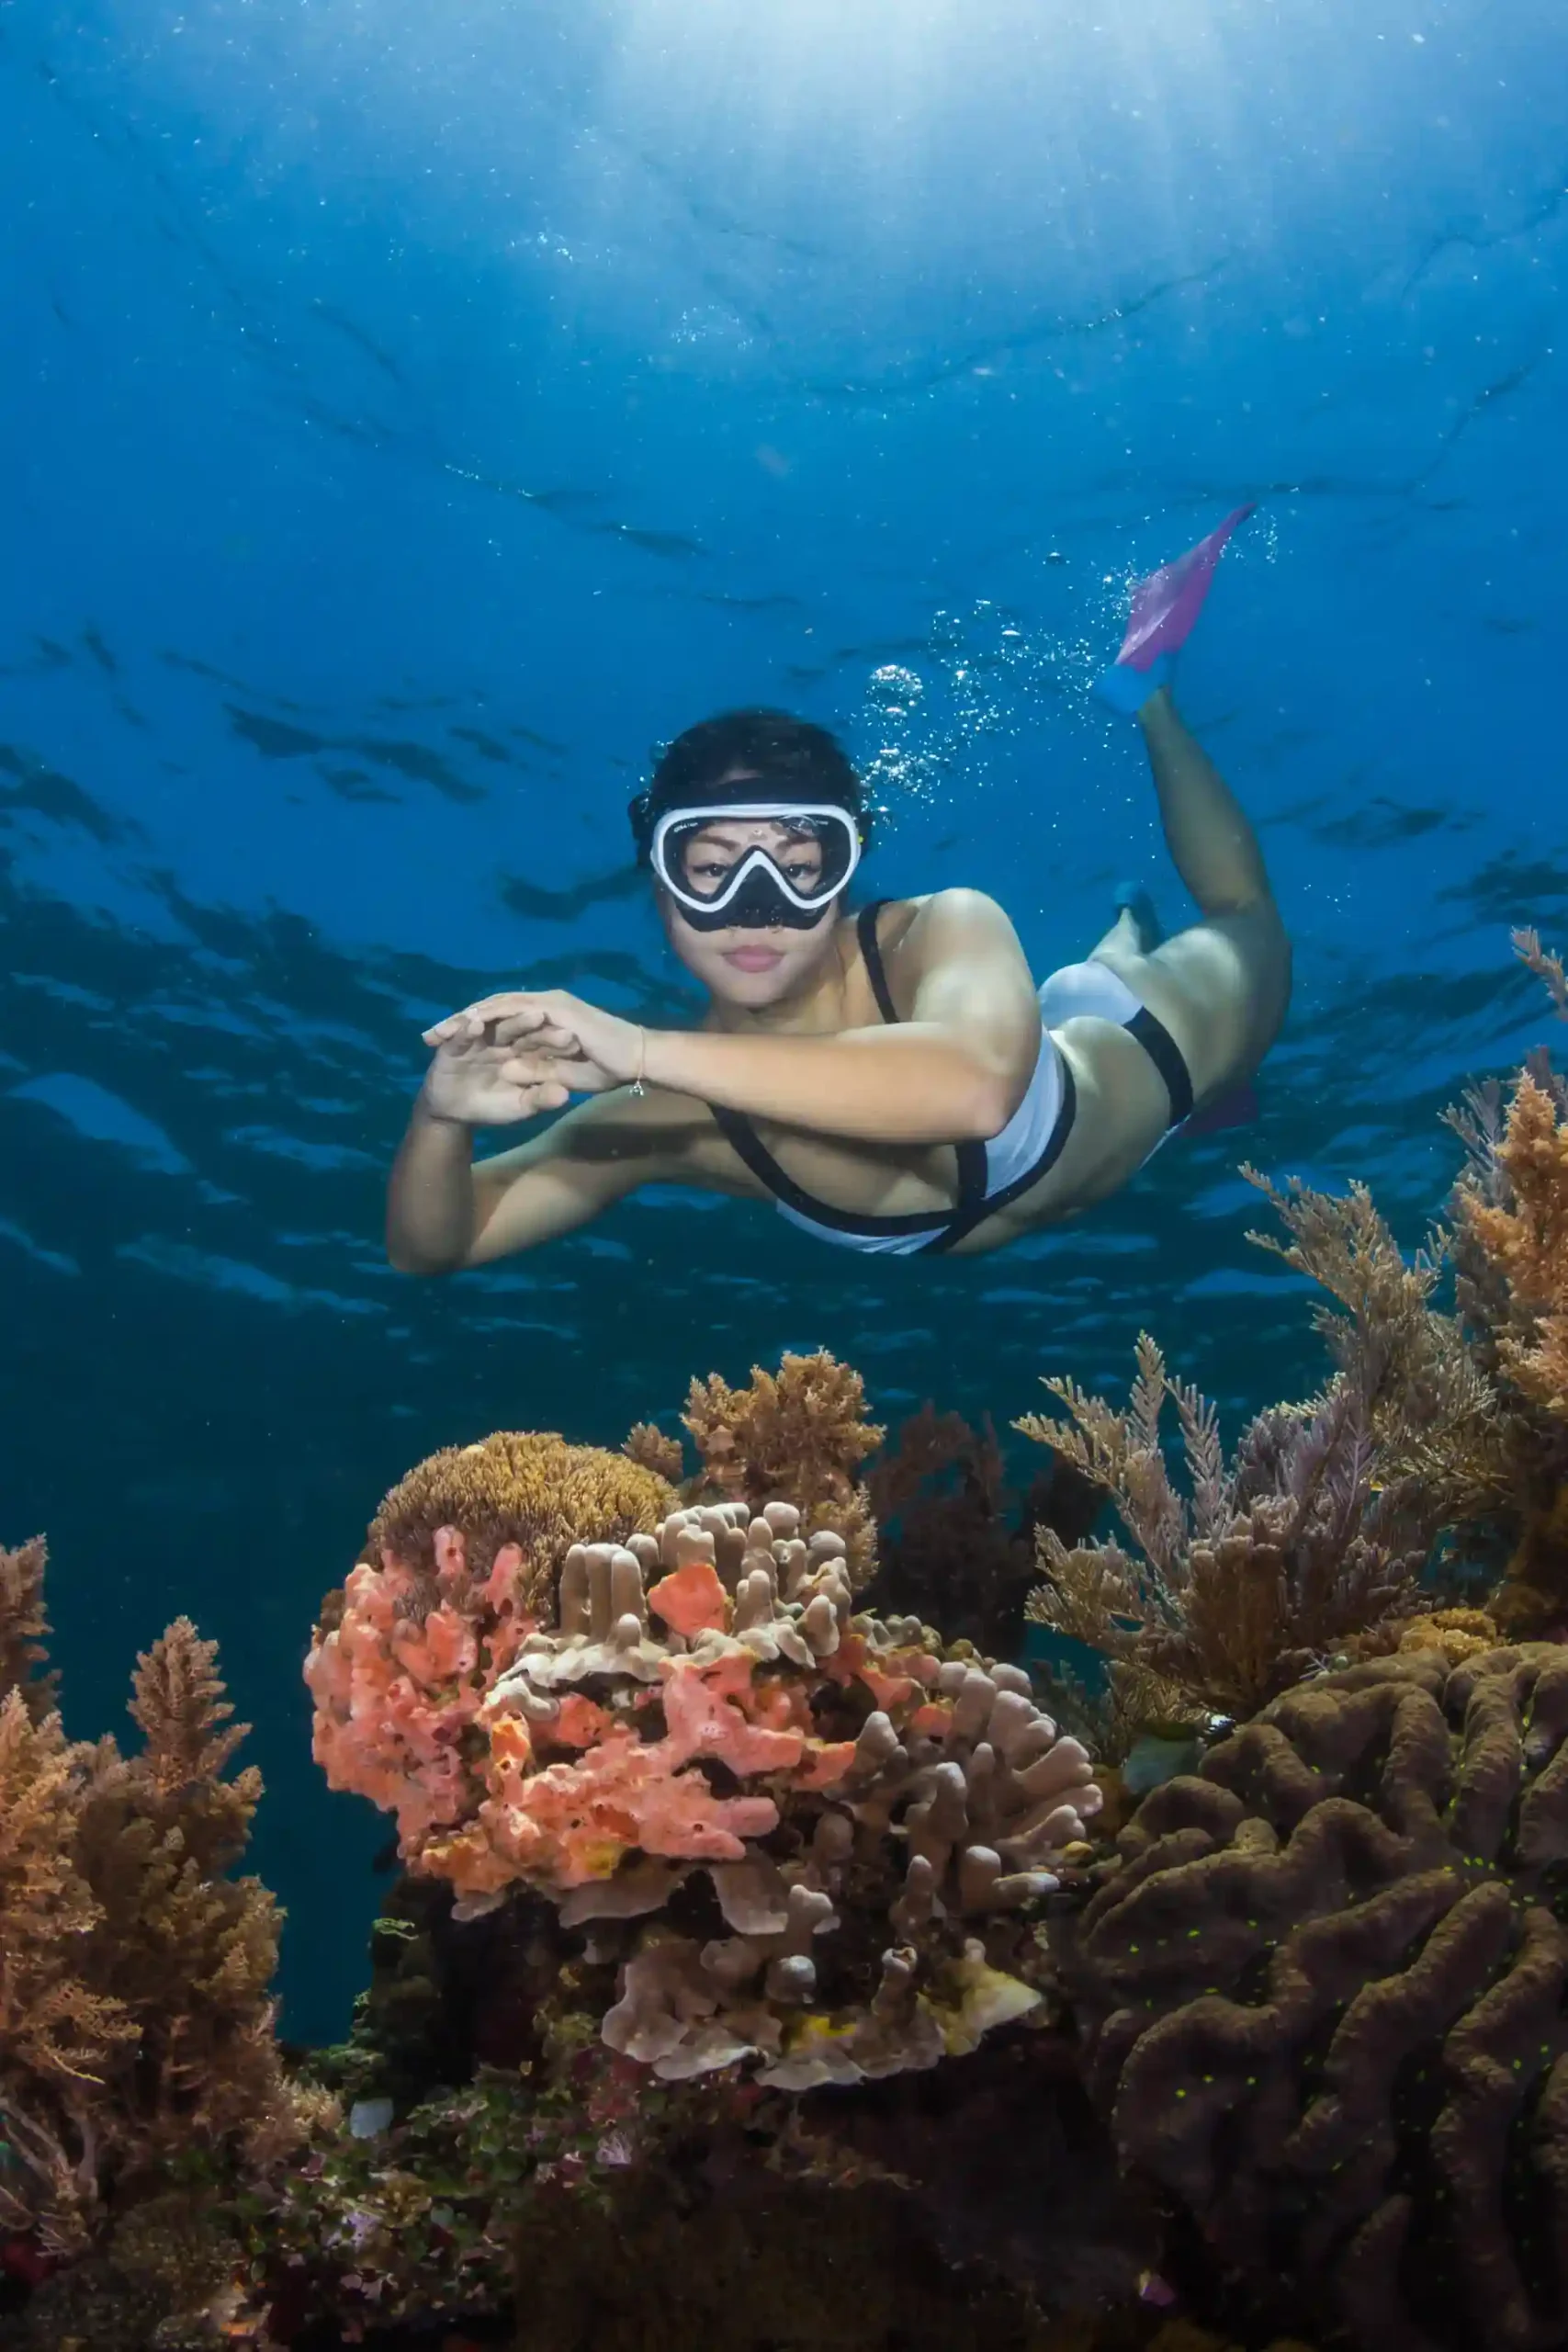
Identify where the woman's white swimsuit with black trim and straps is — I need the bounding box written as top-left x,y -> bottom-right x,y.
707,899 -> 1192,1256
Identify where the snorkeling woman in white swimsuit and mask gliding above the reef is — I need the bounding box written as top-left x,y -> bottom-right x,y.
388,508 -> 1291,1272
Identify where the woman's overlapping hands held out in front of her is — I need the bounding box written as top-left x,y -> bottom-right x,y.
423,988 -> 647,1126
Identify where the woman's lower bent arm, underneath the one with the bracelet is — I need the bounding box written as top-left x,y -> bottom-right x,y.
386,1093 -> 691,1275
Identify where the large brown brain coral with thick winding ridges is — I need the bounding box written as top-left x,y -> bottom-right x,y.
1058,1644 -> 1568,2352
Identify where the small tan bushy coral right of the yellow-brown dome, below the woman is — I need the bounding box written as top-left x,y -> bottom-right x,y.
684,1350 -> 884,1592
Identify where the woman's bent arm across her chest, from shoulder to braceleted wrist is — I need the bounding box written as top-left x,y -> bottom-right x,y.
647,889 -> 1039,1143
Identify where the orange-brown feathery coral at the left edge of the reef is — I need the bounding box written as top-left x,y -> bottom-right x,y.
0,1555 -> 296,2253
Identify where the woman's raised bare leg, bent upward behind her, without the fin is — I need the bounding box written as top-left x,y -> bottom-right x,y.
1093,689 -> 1291,1103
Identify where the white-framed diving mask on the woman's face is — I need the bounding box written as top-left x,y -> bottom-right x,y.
649,799 -> 861,932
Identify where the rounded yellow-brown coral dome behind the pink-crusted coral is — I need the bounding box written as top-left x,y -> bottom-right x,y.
360,1430 -> 674,1611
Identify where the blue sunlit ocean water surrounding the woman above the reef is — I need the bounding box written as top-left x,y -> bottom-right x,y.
0,0 -> 1568,2034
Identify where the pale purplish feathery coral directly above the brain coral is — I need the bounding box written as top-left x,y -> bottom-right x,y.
1018,1334 -> 1427,1714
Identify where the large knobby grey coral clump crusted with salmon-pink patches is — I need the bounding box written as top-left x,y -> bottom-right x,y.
308,1500 -> 1098,2088
